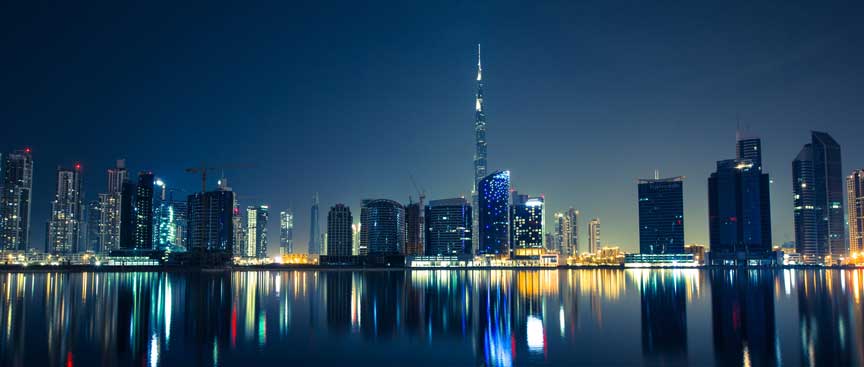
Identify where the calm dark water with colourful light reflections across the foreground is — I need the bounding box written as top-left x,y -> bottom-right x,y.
0,269 -> 864,366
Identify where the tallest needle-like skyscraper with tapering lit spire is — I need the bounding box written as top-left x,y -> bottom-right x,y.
471,44 -> 486,258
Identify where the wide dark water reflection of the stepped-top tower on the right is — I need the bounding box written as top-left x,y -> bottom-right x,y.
710,269 -> 779,366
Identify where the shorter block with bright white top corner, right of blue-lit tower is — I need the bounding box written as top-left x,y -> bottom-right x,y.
510,195 -> 544,257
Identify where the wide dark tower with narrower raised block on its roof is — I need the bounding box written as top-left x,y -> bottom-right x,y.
708,134 -> 774,265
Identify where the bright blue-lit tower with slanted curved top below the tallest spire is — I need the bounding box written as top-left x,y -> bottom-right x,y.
477,171 -> 510,255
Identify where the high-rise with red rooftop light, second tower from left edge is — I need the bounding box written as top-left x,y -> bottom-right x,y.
46,163 -> 84,254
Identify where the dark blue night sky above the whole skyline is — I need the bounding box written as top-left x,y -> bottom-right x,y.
0,1 -> 864,253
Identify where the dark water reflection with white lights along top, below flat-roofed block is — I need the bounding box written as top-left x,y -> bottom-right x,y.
635,270 -> 687,365
